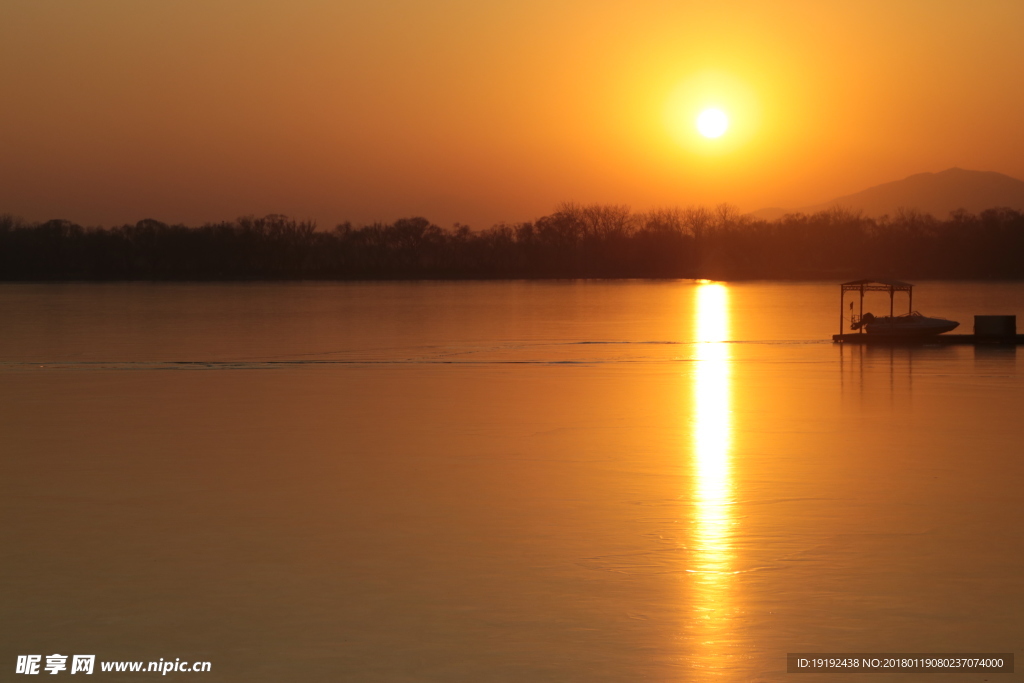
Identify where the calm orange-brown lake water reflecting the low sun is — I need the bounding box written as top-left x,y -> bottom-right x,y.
0,282 -> 1024,683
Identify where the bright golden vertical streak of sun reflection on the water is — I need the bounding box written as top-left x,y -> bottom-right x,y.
690,283 -> 733,674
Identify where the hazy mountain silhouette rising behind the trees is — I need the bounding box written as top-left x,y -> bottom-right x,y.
751,168 -> 1024,220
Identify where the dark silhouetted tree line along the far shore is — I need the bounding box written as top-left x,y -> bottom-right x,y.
0,204 -> 1024,281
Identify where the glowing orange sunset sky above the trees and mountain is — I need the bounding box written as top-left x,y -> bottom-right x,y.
0,0 -> 1024,227
